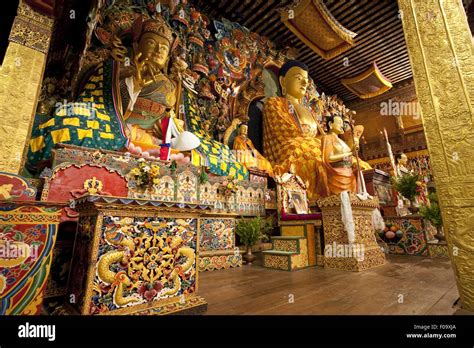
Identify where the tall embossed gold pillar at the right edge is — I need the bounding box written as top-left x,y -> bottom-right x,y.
398,0 -> 474,311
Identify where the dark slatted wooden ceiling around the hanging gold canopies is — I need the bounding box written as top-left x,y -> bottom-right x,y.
194,0 -> 412,102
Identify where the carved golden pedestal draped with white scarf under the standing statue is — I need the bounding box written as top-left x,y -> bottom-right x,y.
318,194 -> 385,271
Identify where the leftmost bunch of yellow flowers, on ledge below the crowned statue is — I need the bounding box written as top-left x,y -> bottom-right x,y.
129,158 -> 160,198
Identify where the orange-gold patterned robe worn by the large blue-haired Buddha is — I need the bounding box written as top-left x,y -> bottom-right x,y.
263,97 -> 321,200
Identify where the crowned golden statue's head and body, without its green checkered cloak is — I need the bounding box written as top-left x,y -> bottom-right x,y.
120,17 -> 196,159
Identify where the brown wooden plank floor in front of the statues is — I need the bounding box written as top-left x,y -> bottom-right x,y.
199,255 -> 459,314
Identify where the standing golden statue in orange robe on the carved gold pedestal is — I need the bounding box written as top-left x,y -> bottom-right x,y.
318,116 -> 357,197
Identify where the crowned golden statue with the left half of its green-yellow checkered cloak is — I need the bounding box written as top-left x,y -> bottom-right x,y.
27,16 -> 196,170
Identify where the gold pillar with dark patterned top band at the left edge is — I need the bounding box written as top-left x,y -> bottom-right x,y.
0,2 -> 53,174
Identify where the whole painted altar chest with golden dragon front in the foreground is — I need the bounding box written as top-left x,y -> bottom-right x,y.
64,195 -> 210,315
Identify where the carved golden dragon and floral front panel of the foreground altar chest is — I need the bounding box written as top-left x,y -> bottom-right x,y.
90,216 -> 197,314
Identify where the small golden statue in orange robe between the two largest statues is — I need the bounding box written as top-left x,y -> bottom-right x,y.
233,124 -> 273,177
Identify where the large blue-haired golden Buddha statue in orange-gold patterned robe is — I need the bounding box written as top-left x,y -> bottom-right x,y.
263,60 -> 324,200
